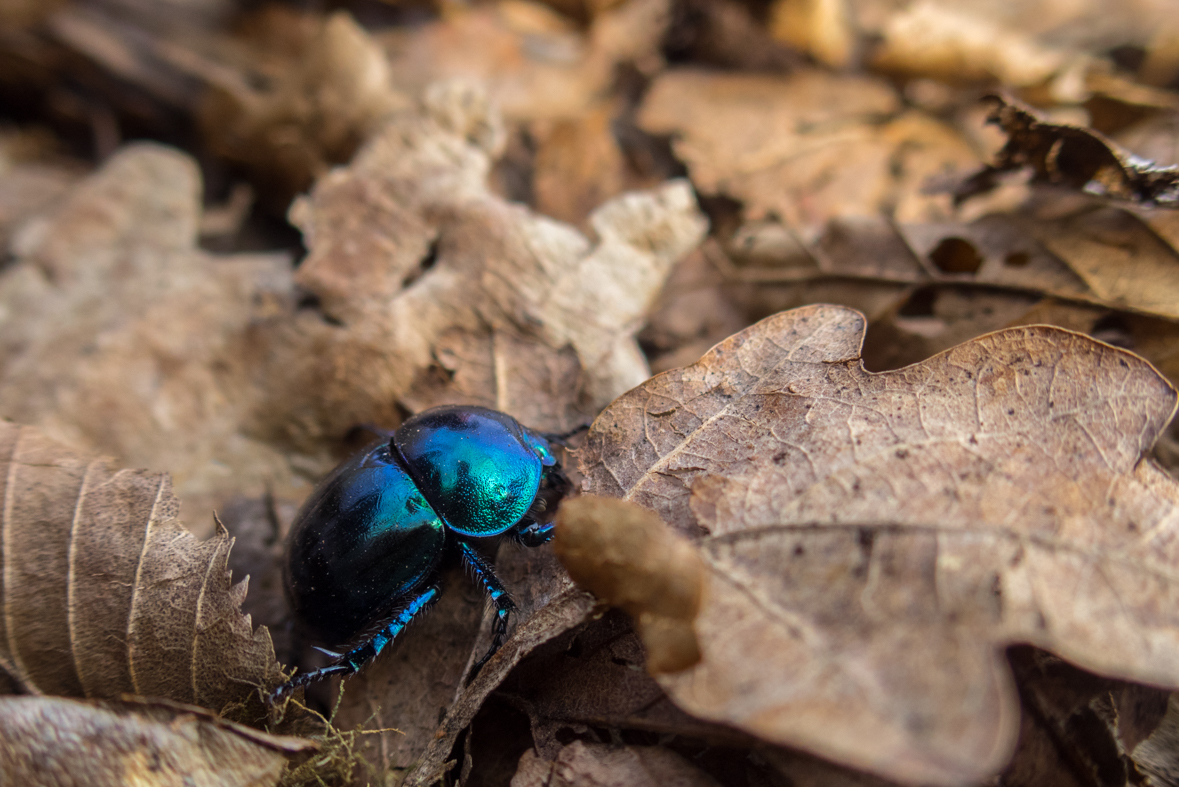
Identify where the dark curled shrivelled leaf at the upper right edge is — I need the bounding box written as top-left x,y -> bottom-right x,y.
954,95 -> 1179,207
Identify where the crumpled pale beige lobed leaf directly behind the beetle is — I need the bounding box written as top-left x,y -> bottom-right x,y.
278,81 -> 706,442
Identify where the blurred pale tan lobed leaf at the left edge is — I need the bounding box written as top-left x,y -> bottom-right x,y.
0,145 -> 304,533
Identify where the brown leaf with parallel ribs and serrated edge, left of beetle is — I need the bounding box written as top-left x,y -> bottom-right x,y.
0,422 -> 281,716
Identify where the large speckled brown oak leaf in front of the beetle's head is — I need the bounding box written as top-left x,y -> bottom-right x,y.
580,305 -> 1179,785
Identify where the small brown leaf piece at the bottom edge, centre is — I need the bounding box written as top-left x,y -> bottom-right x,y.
512,741 -> 720,787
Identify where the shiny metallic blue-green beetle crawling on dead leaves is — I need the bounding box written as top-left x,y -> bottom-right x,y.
271,406 -> 571,702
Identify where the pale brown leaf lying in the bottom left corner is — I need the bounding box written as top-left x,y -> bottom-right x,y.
0,696 -> 315,787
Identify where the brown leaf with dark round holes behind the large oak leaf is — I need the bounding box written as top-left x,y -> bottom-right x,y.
674,202 -> 1179,383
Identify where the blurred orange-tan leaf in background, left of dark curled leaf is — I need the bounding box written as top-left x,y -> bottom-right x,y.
638,70 -> 979,237
